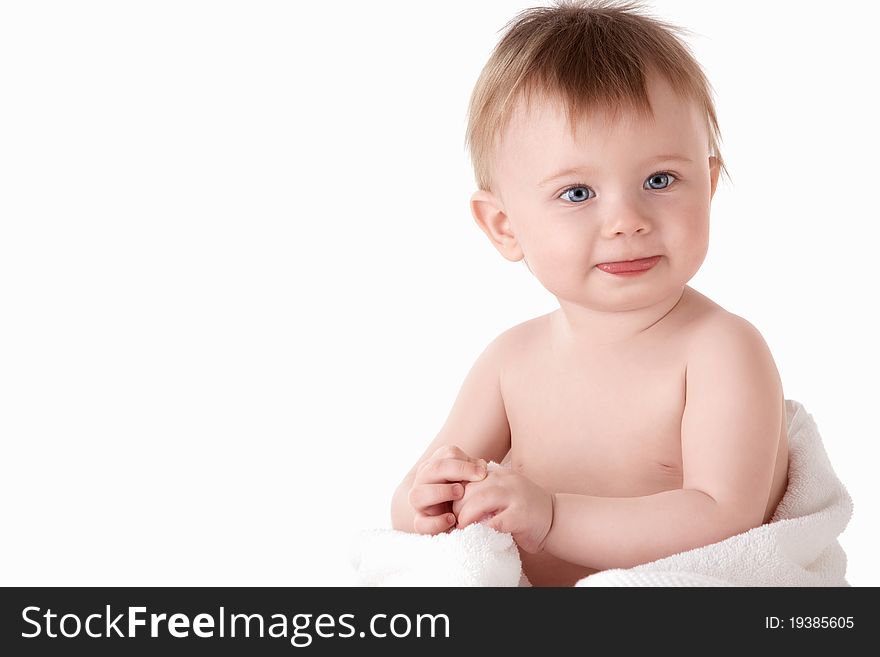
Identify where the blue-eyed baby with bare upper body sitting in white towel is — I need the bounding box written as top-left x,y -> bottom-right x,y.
392,2 -> 788,586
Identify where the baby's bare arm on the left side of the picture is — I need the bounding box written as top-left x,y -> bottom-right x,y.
391,332 -> 510,534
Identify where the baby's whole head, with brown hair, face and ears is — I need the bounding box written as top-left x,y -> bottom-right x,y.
467,1 -> 726,310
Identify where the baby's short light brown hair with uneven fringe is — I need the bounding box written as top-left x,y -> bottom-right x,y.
465,0 -> 730,191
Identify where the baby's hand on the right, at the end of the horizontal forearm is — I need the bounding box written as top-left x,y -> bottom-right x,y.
453,469 -> 555,554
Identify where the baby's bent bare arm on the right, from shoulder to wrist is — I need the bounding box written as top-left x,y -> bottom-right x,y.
544,315 -> 782,570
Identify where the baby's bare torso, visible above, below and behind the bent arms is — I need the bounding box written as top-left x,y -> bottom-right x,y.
501,287 -> 788,586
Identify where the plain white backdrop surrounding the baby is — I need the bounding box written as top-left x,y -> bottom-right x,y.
0,0 -> 880,586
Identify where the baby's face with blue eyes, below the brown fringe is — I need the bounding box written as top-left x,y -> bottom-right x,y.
472,73 -> 718,310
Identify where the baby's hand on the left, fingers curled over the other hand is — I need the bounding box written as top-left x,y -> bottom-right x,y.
409,445 -> 486,534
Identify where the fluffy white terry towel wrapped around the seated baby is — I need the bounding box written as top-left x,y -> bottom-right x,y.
351,399 -> 853,586
